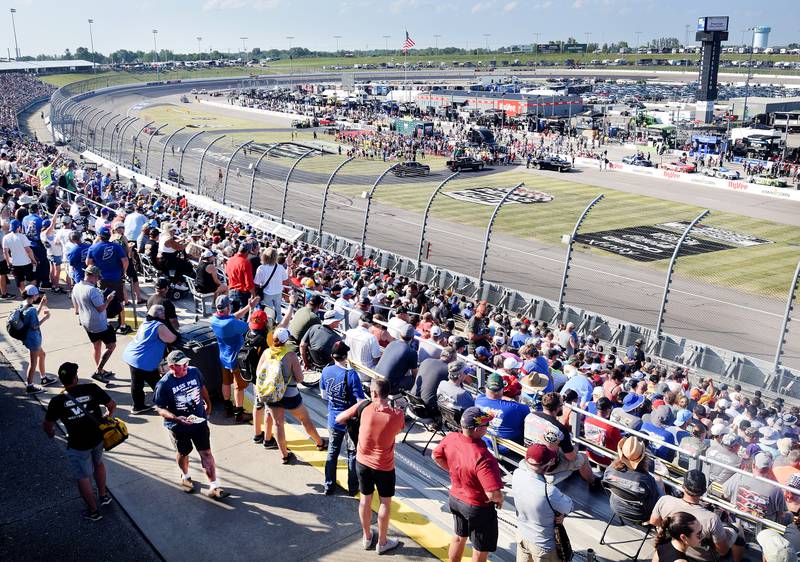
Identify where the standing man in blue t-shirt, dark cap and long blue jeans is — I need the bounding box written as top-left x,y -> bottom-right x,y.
320,341 -> 366,496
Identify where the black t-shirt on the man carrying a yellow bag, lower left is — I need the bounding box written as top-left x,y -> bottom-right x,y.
44,383 -> 111,451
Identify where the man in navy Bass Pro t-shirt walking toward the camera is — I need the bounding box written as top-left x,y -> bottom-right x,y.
154,350 -> 230,500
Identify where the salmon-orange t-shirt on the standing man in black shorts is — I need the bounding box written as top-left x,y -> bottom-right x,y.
356,402 -> 406,471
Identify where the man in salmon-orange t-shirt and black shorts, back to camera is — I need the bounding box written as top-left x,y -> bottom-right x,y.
336,379 -> 405,554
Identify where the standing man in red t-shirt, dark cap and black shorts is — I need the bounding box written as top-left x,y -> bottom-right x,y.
433,406 -> 503,562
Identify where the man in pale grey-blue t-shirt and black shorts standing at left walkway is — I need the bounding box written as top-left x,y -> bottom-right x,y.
72,265 -> 117,384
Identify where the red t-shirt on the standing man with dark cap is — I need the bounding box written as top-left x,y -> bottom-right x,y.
433,432 -> 503,507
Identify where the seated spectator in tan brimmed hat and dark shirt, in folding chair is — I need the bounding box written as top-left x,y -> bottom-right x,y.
603,436 -> 664,523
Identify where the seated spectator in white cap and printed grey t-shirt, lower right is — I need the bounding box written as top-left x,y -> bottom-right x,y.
722,452 -> 788,524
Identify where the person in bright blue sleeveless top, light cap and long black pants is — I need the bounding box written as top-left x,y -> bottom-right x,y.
122,304 -> 177,415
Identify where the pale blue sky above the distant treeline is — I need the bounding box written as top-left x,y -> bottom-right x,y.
6,0 -> 800,55
